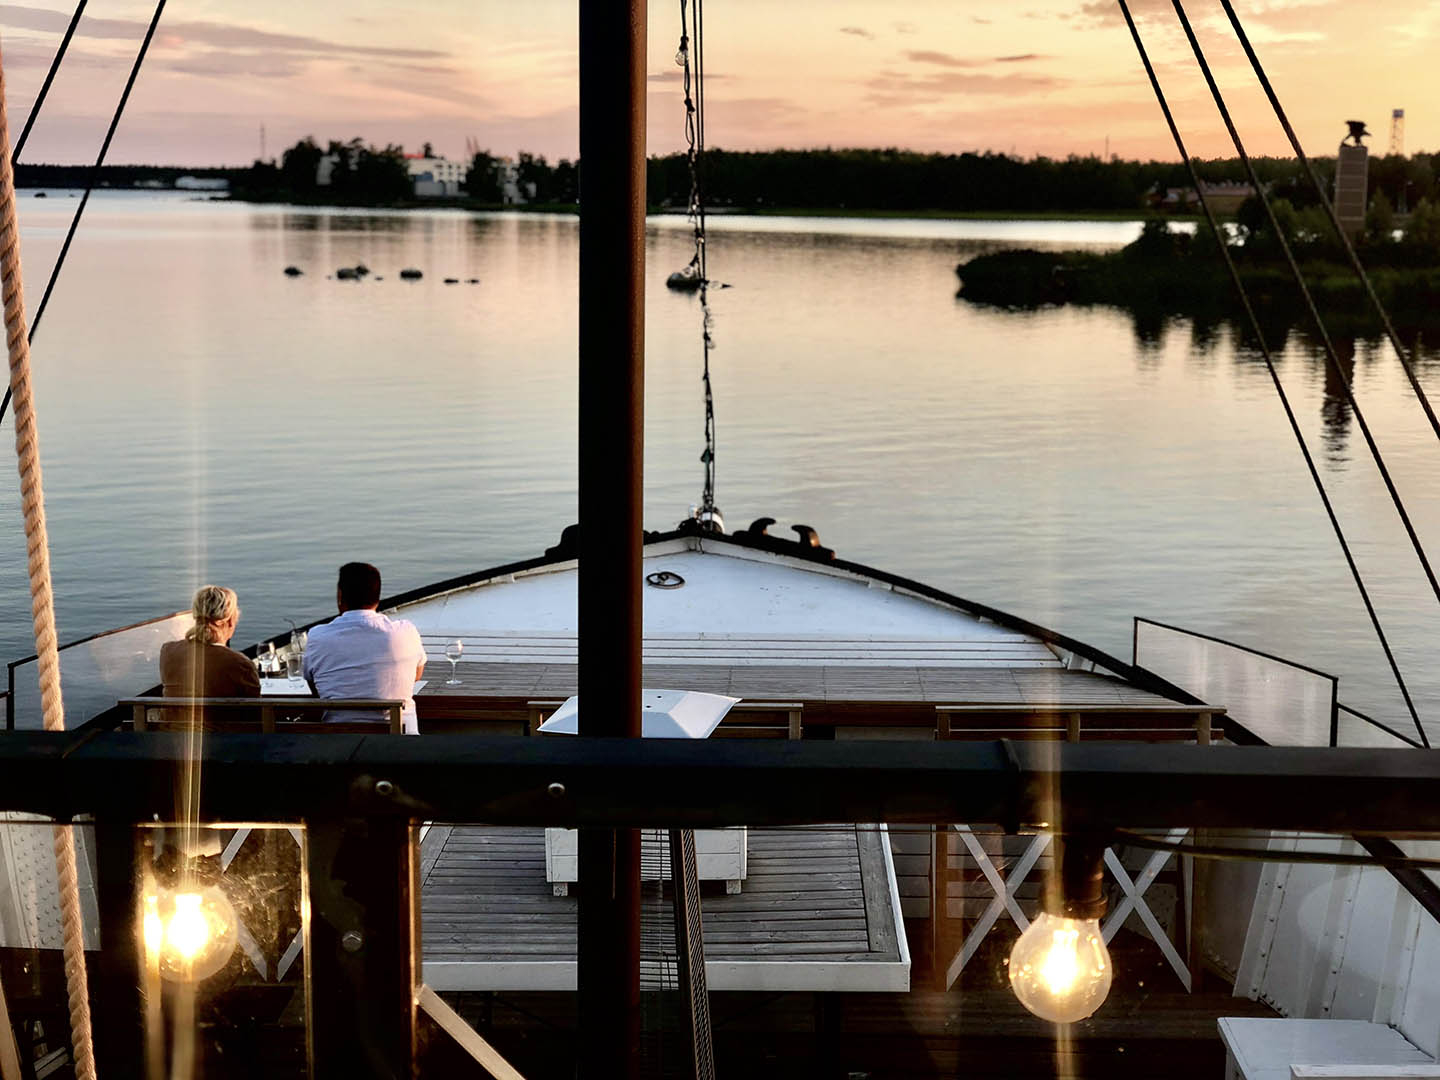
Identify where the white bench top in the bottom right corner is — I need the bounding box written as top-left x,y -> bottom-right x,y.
1217,1017 -> 1440,1080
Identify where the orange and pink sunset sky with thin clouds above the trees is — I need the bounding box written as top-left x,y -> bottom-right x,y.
0,0 -> 1440,164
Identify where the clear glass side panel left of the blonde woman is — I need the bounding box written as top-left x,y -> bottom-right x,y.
10,612 -> 192,732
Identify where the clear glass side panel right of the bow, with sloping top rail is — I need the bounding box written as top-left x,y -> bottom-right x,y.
1135,619 -> 1335,746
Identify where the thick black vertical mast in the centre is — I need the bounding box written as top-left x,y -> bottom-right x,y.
577,0 -> 645,1077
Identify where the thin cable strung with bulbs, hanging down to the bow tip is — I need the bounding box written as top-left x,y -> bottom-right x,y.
675,0 -> 724,531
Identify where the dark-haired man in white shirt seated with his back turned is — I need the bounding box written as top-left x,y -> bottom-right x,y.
304,563 -> 425,734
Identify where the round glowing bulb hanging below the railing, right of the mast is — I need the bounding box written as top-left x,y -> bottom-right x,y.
1009,912 -> 1110,1024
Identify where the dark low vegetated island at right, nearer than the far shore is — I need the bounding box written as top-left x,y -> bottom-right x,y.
956,194 -> 1440,336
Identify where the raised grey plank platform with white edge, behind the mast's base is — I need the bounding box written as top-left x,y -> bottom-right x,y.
420,825 -> 910,991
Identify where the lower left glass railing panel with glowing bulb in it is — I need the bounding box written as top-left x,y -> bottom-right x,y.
0,815 -> 310,1079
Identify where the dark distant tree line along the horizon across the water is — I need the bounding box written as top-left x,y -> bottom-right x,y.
16,146 -> 1440,220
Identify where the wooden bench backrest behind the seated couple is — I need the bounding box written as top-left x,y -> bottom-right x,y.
120,696 -> 405,734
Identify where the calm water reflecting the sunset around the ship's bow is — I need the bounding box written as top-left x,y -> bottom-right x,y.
0,193 -> 1440,733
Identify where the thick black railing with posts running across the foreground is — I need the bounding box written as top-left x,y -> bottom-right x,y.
0,730 -> 1440,1076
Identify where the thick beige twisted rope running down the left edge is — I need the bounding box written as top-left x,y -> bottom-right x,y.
0,33 -> 95,1080
